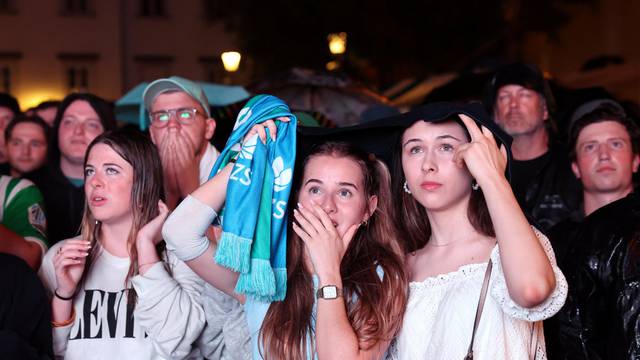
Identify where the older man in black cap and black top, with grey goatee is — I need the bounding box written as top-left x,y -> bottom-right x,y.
485,64 -> 580,232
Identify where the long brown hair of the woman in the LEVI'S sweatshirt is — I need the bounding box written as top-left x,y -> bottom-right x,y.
80,130 -> 164,306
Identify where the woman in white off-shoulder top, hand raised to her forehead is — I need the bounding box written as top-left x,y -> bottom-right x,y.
390,104 -> 567,360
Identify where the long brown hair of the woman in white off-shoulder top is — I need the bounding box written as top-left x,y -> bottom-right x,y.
393,117 -> 495,253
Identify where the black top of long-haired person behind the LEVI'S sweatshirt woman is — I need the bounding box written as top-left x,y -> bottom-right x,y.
25,165 -> 85,246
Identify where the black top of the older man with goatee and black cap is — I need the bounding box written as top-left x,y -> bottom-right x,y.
511,144 -> 582,233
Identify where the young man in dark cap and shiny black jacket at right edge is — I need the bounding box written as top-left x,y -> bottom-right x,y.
545,100 -> 640,359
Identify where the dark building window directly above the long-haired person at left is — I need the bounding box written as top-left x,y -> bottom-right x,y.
58,53 -> 99,92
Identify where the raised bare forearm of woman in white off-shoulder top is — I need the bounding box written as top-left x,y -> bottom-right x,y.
483,177 -> 555,307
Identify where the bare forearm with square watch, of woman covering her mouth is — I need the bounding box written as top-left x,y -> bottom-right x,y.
314,274 -> 389,360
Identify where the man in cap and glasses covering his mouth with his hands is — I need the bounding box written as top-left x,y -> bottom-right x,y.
142,76 -> 251,360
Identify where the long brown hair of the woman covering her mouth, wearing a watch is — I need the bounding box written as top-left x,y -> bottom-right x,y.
259,142 -> 407,360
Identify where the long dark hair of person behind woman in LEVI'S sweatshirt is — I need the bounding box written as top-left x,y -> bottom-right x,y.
49,93 -> 116,164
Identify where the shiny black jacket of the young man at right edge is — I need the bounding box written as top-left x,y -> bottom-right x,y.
545,193 -> 640,360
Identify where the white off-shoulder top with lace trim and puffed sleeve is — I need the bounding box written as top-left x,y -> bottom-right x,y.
389,229 -> 567,360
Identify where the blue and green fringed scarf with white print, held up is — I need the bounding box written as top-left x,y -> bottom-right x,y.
209,95 -> 297,302
